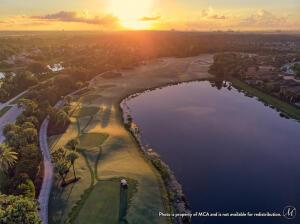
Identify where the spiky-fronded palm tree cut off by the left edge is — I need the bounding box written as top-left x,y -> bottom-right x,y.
0,144 -> 18,171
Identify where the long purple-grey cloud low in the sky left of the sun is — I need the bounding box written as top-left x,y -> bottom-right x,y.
30,11 -> 119,26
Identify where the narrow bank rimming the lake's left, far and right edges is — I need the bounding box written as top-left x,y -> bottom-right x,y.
119,77 -> 300,224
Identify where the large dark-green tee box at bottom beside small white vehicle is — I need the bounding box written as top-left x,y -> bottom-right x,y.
74,179 -> 136,224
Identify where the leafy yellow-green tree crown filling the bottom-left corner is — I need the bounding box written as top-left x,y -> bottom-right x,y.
0,194 -> 41,224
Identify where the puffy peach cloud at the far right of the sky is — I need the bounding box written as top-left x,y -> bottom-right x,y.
239,9 -> 288,27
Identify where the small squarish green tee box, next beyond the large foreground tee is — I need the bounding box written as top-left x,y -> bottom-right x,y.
79,133 -> 108,149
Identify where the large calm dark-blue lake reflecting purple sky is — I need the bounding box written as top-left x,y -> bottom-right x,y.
127,81 -> 300,224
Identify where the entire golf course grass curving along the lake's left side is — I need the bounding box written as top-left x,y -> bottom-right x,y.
49,55 -> 212,224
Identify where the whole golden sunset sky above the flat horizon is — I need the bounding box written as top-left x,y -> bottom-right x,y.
0,0 -> 300,31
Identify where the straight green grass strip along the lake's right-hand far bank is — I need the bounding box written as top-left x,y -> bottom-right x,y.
230,79 -> 300,120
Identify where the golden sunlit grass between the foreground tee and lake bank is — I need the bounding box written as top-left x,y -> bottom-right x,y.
97,133 -> 168,224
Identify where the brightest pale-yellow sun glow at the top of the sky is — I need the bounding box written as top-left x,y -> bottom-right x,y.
109,0 -> 153,29
